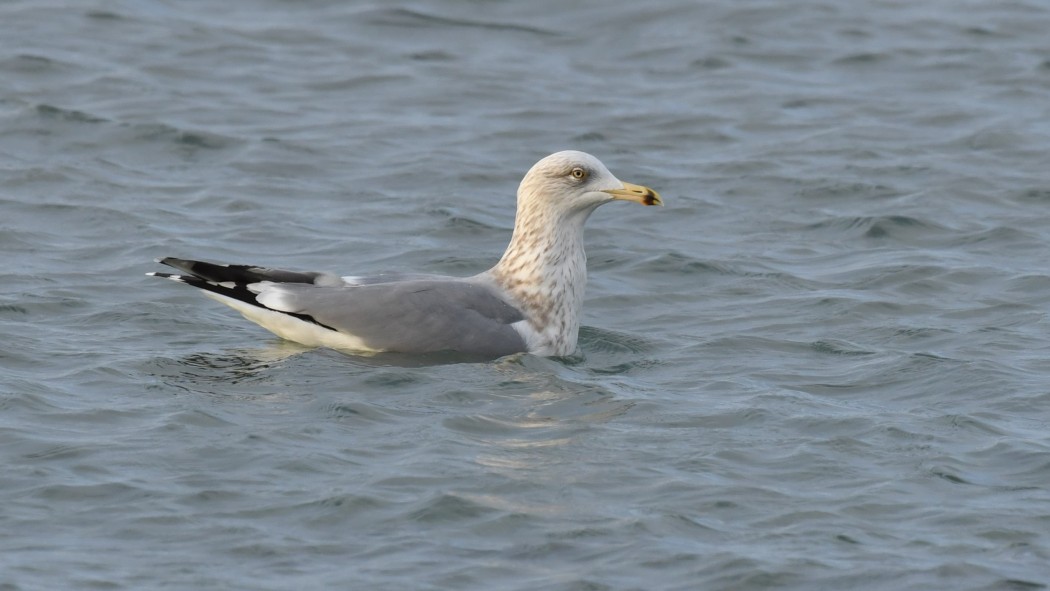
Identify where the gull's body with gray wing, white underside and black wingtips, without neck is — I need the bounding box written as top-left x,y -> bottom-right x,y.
153,258 -> 526,357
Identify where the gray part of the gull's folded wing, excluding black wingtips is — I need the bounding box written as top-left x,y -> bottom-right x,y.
258,278 -> 527,357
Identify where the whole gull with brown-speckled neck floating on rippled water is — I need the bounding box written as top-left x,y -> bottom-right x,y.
151,151 -> 662,357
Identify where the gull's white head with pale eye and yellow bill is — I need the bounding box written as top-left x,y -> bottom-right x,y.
518,150 -> 664,217
